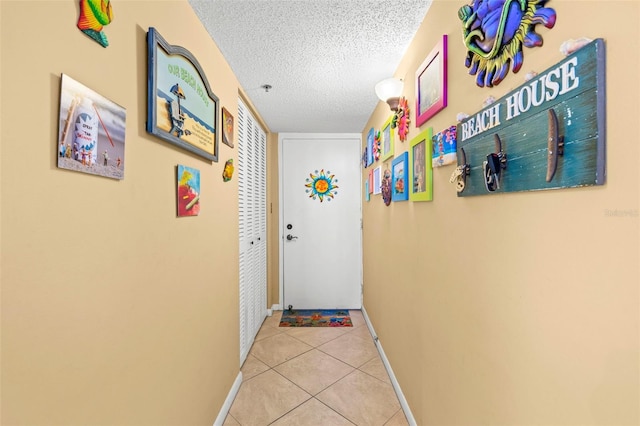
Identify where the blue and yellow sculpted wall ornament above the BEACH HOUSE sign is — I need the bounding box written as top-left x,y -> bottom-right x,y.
458,0 -> 556,87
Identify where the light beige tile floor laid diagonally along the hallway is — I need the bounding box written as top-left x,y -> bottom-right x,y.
224,311 -> 408,426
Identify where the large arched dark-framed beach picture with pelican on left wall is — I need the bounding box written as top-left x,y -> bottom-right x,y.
147,27 -> 218,161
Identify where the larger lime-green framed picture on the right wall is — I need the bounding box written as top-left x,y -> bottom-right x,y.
409,127 -> 433,201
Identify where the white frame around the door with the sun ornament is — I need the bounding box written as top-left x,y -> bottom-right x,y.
273,133 -> 364,310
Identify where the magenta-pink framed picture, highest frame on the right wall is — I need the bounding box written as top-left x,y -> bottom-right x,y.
416,34 -> 447,127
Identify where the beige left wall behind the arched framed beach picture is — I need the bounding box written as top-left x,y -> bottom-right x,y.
0,0 -> 260,425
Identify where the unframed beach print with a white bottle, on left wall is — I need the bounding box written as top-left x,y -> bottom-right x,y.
58,74 -> 127,179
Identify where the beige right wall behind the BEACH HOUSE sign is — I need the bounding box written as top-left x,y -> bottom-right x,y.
363,0 -> 640,425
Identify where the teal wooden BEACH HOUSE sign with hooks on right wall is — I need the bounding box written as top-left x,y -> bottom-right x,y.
457,39 -> 606,197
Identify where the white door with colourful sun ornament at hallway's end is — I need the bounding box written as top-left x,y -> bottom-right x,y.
279,134 -> 362,309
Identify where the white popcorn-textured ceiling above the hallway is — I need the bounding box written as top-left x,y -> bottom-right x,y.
189,0 -> 431,133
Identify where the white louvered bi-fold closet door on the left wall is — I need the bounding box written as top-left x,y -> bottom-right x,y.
237,99 -> 267,363
